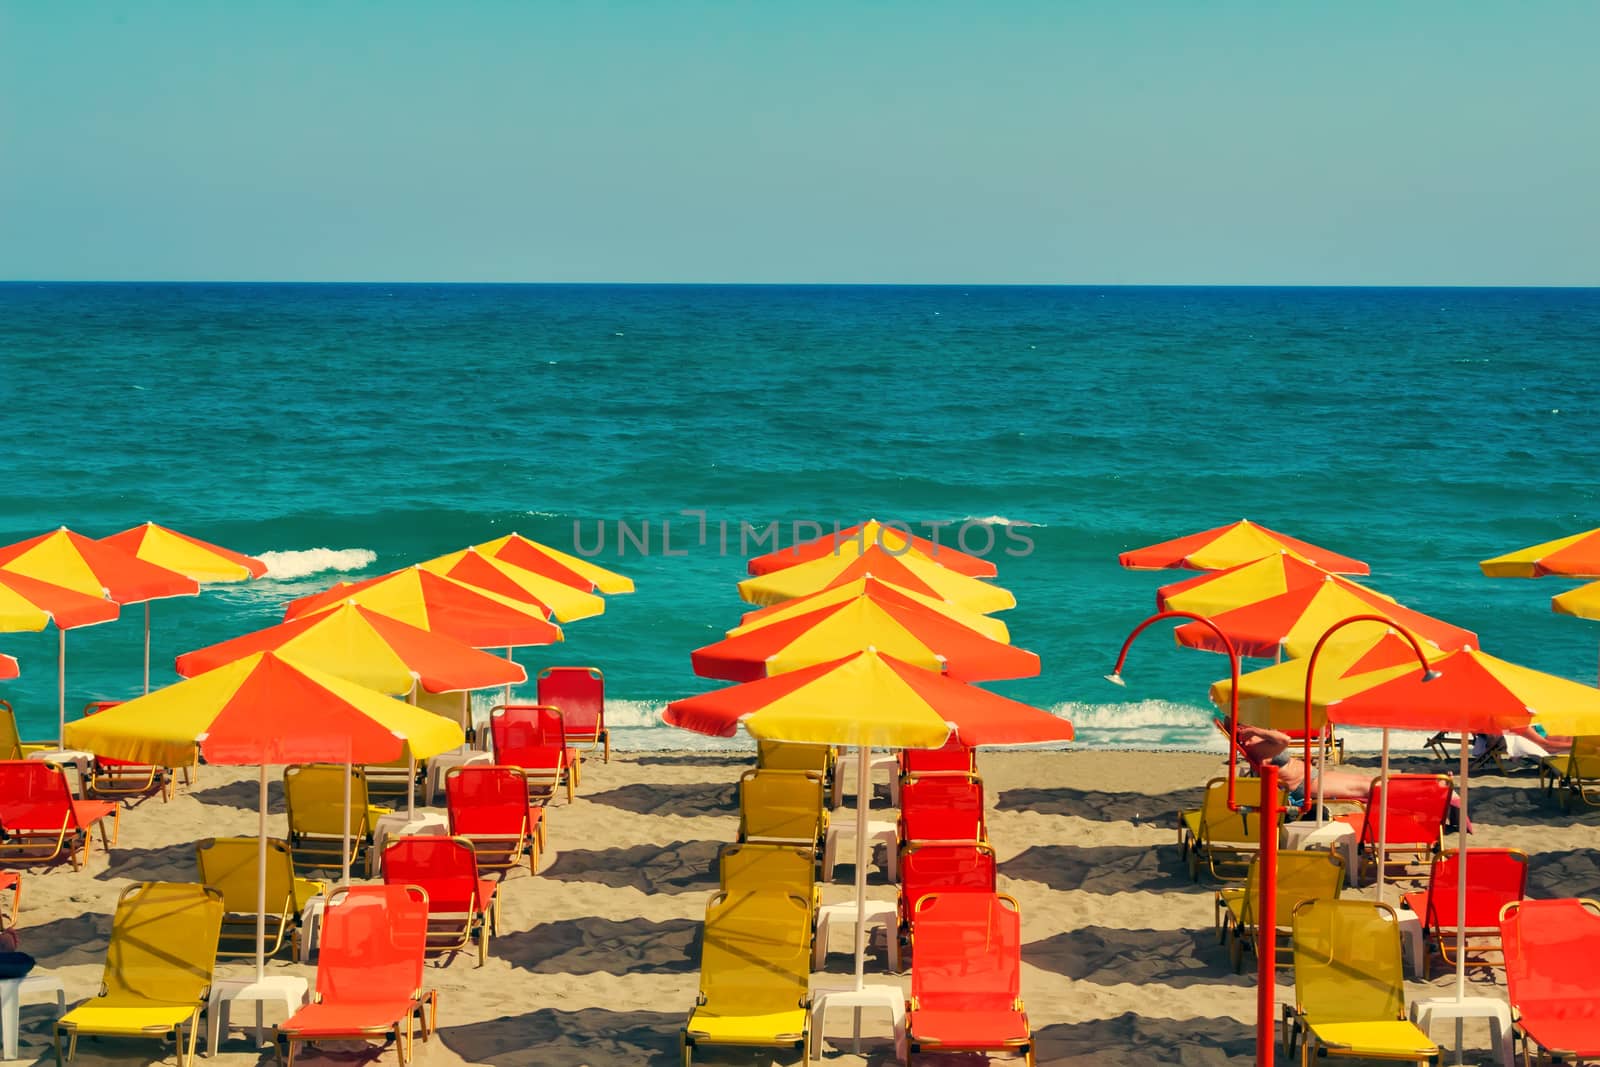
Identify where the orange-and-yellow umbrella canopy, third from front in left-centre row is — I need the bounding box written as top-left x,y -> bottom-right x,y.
283,566 -> 562,648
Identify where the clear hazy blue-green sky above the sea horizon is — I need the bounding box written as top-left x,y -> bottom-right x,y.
0,0 -> 1600,285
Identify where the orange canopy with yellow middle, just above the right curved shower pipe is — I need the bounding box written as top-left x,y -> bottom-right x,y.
1174,576 -> 1478,659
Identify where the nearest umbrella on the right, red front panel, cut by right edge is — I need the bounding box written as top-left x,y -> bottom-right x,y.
1326,648 -> 1600,1030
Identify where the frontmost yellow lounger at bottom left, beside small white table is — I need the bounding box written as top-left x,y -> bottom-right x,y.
56,881 -> 224,1067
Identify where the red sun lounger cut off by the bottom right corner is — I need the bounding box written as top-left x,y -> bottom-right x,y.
1497,895 -> 1600,1064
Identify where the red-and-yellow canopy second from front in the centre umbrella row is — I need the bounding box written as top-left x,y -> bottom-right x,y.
691,597 -> 1038,681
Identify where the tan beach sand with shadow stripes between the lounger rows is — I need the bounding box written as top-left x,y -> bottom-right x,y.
19,752 -> 1600,1067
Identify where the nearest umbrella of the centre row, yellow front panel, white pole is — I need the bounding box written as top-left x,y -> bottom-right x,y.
662,649 -> 1072,992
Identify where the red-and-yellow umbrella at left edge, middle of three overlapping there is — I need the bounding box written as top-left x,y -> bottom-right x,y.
0,526 -> 200,739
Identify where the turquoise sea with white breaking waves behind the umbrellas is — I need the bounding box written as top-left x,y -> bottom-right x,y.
0,283 -> 1600,747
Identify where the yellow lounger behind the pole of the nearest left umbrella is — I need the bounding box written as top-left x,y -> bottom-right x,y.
195,837 -> 328,957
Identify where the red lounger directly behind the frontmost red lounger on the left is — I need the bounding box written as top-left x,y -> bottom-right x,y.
384,833 -> 499,966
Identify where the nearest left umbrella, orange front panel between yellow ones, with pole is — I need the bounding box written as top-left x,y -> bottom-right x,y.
66,653 -> 462,982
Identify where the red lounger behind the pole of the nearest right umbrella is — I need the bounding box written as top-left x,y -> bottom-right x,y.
1402,848 -> 1528,966
